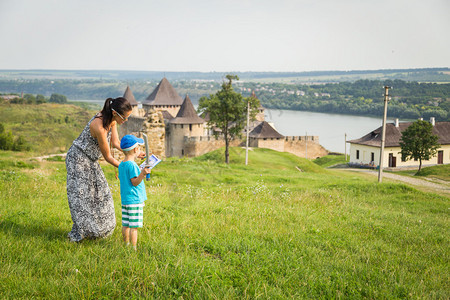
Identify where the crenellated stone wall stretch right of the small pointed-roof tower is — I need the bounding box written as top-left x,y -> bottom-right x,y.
284,136 -> 328,159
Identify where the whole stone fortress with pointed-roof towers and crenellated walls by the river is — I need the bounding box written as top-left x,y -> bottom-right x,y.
119,78 -> 328,158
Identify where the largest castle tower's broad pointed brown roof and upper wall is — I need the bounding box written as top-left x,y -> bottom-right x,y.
142,77 -> 183,116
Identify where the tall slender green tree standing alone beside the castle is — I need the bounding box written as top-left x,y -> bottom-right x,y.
198,75 -> 259,164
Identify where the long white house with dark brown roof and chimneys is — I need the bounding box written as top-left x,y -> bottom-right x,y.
348,118 -> 450,168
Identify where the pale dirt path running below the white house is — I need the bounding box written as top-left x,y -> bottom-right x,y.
342,169 -> 450,196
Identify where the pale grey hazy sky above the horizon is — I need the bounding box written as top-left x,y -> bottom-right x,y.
0,0 -> 450,72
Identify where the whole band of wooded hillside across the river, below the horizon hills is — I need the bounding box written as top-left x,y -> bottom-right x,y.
0,75 -> 450,121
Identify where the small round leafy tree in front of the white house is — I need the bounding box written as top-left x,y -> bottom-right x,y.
399,120 -> 440,172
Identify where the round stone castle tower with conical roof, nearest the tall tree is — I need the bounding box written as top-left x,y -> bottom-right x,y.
166,95 -> 205,157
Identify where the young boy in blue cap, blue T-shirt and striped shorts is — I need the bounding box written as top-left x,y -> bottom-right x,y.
119,134 -> 150,250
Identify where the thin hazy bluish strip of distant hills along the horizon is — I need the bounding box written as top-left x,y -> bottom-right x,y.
0,67 -> 450,83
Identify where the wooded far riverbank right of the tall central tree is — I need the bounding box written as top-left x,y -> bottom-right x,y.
237,80 -> 450,121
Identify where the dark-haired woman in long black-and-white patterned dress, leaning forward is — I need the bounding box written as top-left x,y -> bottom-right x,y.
66,97 -> 132,242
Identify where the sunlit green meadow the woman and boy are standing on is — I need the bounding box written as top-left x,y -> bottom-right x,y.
0,148 -> 450,299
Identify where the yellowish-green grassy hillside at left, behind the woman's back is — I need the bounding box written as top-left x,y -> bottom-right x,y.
0,103 -> 95,154
